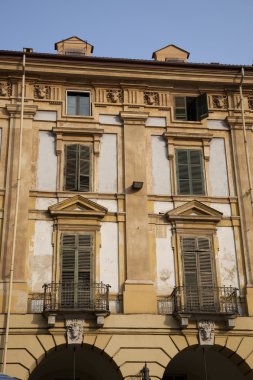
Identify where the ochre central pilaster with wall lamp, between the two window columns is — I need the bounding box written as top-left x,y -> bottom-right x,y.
120,111 -> 156,313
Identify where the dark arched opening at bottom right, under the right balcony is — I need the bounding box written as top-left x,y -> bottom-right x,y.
162,339 -> 253,380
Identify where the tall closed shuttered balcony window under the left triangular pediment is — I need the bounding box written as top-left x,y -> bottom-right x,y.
60,233 -> 93,309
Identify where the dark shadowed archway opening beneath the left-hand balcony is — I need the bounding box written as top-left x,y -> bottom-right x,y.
29,345 -> 122,380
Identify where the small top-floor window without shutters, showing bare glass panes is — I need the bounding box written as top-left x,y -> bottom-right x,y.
67,91 -> 91,116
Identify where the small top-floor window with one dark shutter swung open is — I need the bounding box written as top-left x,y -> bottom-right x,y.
174,94 -> 208,121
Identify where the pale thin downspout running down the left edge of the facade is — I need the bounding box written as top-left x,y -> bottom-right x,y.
2,49 -> 27,373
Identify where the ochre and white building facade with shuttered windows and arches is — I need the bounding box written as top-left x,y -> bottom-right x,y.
0,37 -> 253,380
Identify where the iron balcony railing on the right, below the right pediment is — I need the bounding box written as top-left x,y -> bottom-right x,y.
172,286 -> 239,314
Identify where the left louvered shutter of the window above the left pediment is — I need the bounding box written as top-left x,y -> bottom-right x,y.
65,144 -> 79,191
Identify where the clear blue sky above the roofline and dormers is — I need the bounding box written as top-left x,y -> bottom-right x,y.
0,0 -> 253,65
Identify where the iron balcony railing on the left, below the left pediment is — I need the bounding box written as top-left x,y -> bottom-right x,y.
43,282 -> 110,313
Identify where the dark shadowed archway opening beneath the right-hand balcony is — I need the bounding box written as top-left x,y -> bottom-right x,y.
162,346 -> 249,380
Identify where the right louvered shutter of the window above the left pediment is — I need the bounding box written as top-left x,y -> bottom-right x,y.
78,145 -> 91,191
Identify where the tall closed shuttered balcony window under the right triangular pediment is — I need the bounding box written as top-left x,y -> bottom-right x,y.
181,237 -> 215,312
